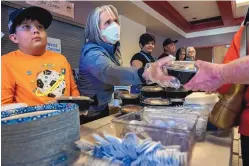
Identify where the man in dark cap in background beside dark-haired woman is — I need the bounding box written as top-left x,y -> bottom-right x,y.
158,38 -> 178,59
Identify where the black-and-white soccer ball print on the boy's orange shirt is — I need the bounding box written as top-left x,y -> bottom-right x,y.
35,69 -> 66,98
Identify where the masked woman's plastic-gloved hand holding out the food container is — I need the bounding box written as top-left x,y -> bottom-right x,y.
143,56 -> 181,89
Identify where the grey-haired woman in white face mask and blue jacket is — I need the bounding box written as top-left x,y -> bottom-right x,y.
77,5 -> 177,123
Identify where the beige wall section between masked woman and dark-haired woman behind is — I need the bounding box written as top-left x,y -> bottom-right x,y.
119,15 -> 146,66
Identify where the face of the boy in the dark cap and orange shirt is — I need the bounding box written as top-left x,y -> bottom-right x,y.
9,20 -> 47,52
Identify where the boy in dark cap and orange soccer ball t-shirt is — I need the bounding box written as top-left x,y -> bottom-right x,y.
1,7 -> 79,106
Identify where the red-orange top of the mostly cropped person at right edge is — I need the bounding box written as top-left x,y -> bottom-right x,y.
218,26 -> 249,136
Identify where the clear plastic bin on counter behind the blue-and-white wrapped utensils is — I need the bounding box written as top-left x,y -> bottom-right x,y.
112,111 -> 199,161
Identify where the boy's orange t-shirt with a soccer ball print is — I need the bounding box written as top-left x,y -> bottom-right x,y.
1,50 -> 79,106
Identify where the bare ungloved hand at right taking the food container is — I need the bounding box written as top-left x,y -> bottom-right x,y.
184,61 -> 223,92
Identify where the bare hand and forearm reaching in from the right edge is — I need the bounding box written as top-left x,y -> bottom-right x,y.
184,56 -> 249,92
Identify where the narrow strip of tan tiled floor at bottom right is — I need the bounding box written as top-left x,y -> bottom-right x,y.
232,128 -> 243,166
